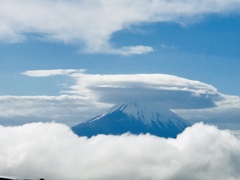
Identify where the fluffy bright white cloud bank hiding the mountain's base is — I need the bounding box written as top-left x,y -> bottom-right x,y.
0,123 -> 240,179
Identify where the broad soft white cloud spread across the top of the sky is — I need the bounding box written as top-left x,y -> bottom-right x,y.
0,0 -> 240,55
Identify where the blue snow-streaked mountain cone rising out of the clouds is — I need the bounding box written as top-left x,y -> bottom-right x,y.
72,102 -> 191,138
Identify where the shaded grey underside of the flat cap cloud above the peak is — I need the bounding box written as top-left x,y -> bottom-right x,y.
92,87 -> 215,109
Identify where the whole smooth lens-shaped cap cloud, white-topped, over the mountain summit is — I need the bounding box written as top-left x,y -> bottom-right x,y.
69,73 -> 221,109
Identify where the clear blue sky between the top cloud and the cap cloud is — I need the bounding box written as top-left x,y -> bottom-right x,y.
0,14 -> 240,95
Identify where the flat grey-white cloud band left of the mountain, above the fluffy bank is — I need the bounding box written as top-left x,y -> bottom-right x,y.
0,95 -> 109,126
